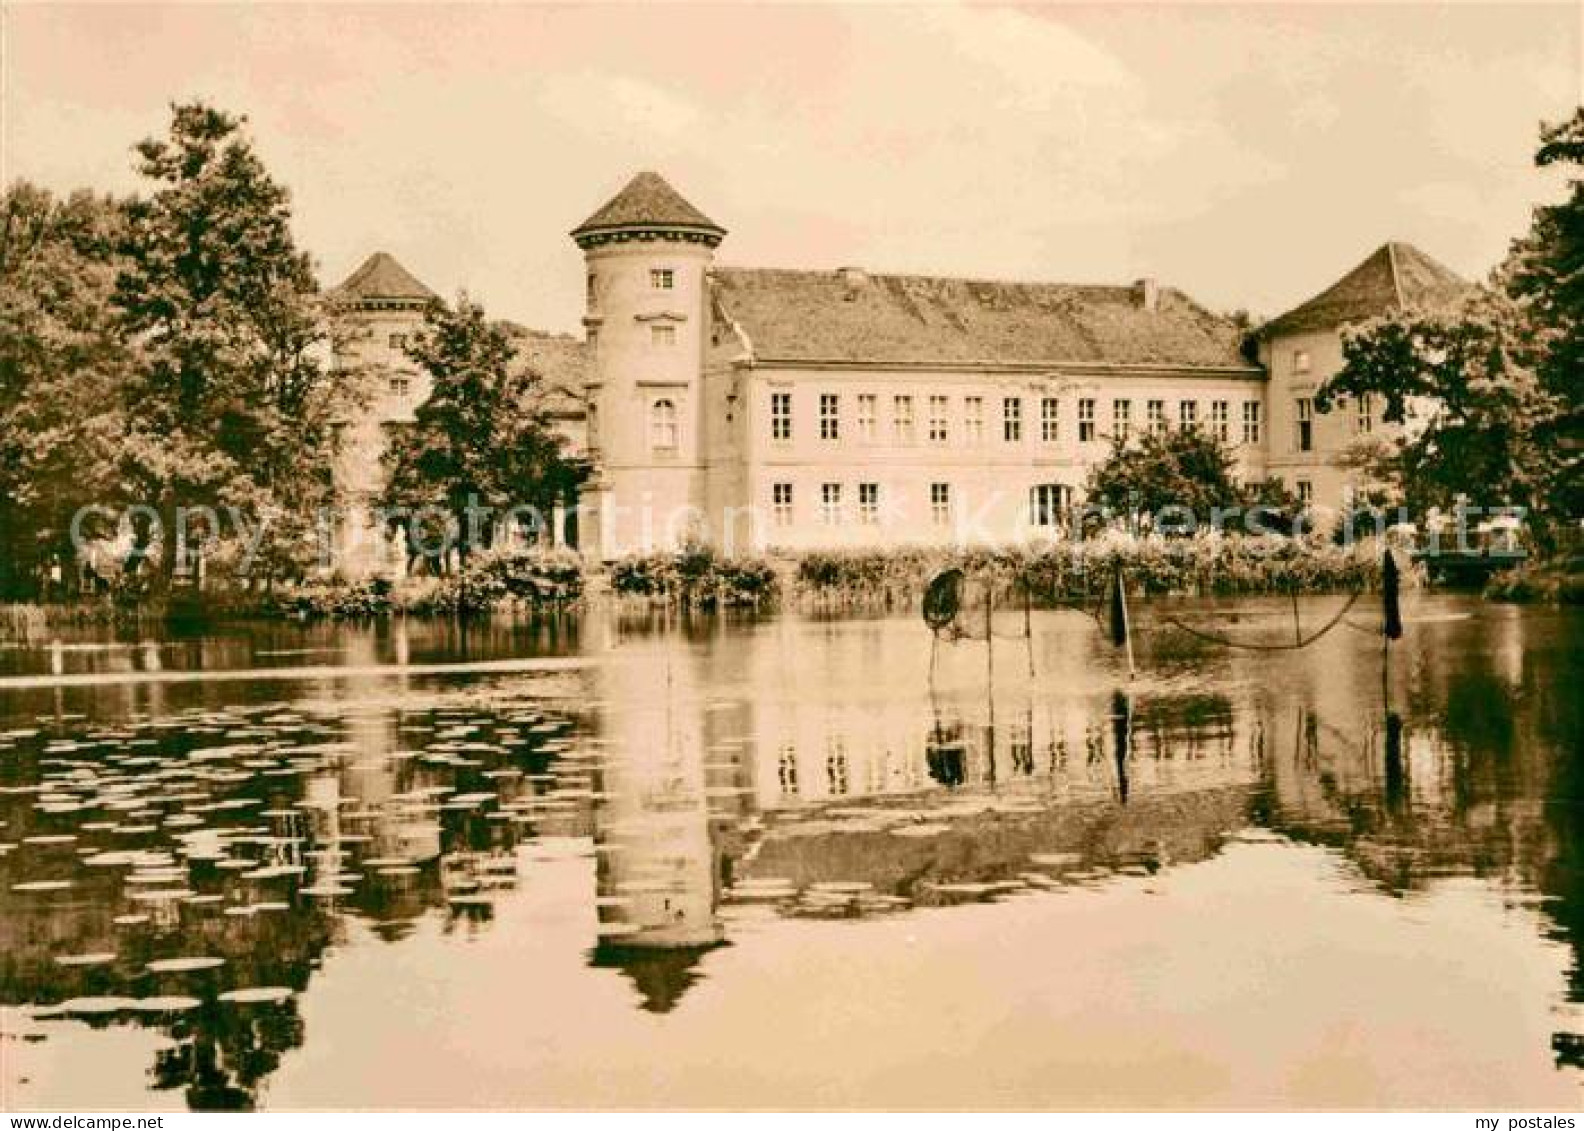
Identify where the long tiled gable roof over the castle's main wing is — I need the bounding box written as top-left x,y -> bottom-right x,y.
714,268 -> 1250,367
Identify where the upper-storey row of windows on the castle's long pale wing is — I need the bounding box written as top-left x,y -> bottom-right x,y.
770,393 -> 1261,444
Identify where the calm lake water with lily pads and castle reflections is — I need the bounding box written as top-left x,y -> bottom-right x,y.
0,596 -> 1584,1110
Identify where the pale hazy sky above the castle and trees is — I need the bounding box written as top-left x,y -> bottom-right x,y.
0,3 -> 1584,329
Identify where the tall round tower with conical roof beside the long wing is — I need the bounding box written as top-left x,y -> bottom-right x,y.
572,173 -> 725,561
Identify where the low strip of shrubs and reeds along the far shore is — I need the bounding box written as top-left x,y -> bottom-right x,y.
9,535 -> 1584,642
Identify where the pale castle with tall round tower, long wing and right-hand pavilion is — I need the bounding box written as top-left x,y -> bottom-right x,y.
572,173 -> 1464,559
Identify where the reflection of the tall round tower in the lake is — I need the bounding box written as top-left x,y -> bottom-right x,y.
594,640 -> 722,1012
